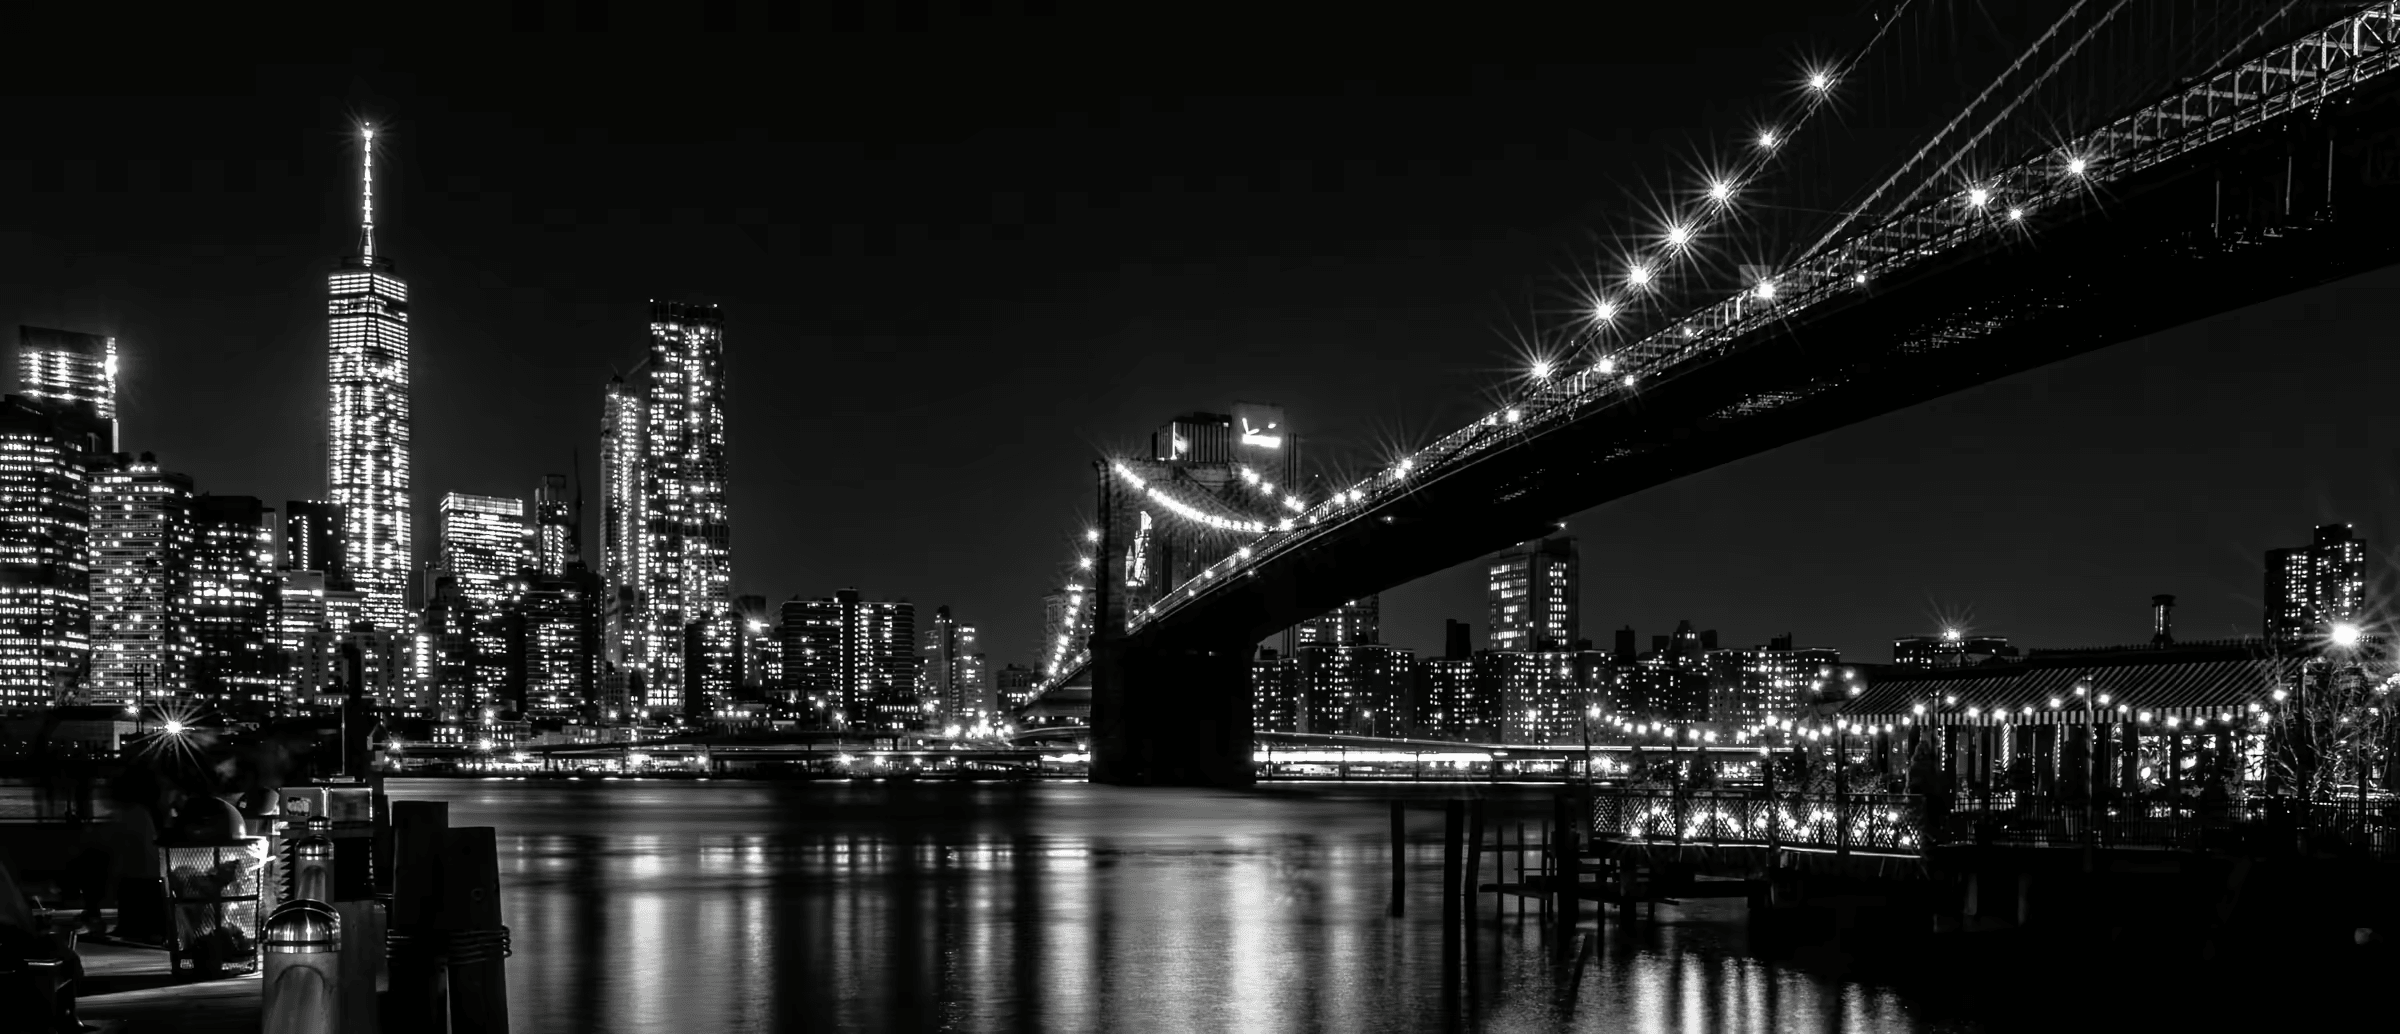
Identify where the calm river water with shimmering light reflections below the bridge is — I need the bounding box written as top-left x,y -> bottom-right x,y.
391,780 -> 2361,1034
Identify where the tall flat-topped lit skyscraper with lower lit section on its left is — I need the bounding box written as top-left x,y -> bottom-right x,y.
600,302 -> 737,715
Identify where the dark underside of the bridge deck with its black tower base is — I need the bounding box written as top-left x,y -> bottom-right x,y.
1092,70 -> 2400,784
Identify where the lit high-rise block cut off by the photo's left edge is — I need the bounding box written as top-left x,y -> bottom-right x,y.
0,396 -> 98,708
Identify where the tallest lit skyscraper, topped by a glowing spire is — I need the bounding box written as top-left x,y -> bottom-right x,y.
326,127 -> 410,633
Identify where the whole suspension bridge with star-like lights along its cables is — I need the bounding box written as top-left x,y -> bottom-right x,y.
998,0 -> 2400,784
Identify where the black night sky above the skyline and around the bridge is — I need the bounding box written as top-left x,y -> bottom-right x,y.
0,2 -> 2400,665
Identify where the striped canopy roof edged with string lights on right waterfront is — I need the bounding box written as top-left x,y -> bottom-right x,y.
1841,650 -> 2393,729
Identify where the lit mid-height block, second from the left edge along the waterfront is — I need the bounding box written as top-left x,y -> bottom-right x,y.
91,453 -> 192,703
